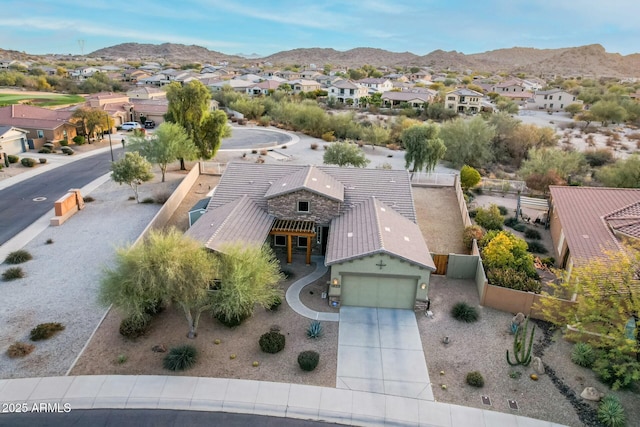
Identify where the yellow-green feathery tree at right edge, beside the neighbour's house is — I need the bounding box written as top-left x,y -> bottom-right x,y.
536,243 -> 640,390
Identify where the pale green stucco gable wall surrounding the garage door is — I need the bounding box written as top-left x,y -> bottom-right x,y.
329,254 -> 431,301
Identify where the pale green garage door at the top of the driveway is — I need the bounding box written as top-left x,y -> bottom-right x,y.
341,275 -> 418,309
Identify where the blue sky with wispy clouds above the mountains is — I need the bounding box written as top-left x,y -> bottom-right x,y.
0,0 -> 640,56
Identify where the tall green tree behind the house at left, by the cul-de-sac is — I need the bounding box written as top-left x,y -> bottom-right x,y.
165,80 -> 231,166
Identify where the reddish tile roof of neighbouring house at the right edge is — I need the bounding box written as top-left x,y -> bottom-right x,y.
549,186 -> 640,260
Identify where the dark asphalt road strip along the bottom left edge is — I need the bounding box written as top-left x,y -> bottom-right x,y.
0,409 -> 337,427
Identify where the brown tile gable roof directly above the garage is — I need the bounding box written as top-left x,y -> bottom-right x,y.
325,197 -> 436,271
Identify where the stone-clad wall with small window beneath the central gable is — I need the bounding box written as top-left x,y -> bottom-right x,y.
267,190 -> 340,225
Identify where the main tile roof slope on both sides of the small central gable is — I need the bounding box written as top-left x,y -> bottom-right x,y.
209,161 -> 416,222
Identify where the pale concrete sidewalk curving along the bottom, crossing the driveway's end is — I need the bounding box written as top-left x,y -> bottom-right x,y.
0,375 -> 560,427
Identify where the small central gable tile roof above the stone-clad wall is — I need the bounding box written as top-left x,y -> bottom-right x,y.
264,166 -> 344,202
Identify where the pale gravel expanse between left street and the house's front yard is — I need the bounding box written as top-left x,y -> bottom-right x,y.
0,174 -> 183,378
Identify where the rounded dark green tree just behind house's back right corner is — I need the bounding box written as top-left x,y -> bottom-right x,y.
400,124 -> 447,175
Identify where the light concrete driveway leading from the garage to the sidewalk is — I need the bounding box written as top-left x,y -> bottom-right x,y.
336,307 -> 434,401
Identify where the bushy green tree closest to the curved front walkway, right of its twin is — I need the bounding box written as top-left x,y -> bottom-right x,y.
211,243 -> 283,324
